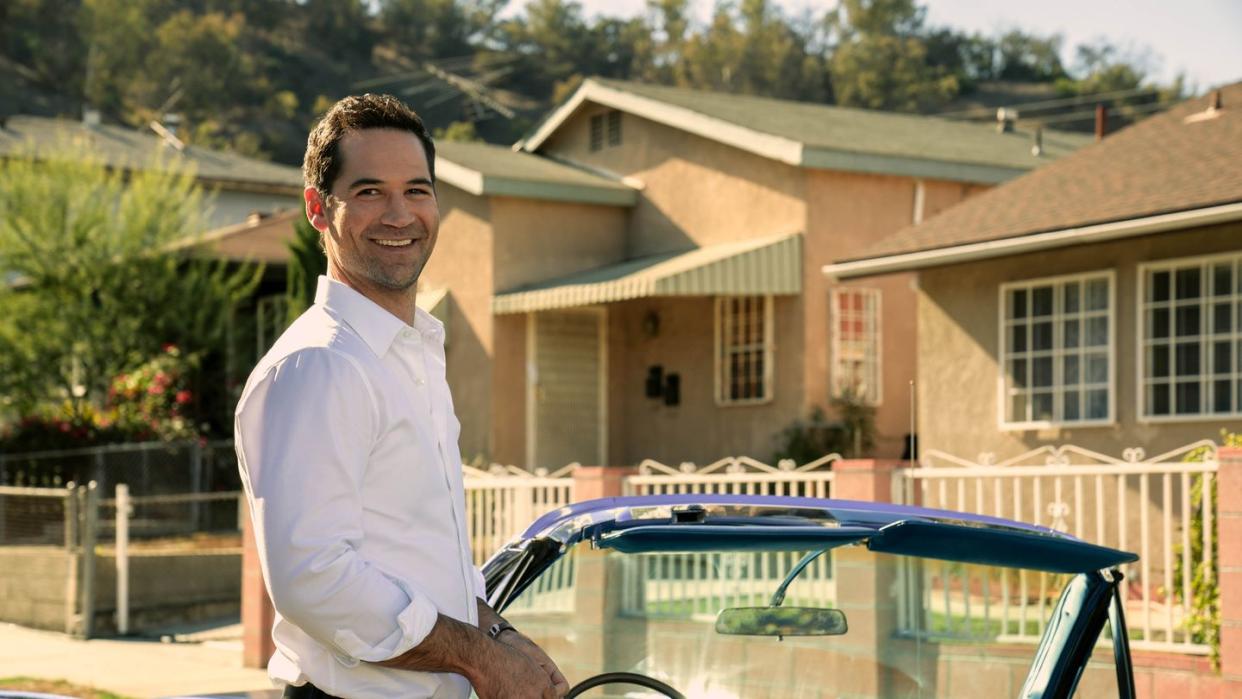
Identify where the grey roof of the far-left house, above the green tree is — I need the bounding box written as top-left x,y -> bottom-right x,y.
0,115 -> 302,195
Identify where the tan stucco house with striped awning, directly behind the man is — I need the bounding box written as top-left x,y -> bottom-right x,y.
415,79 -> 1087,468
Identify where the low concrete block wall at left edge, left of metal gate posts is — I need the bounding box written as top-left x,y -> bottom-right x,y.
0,546 -> 77,631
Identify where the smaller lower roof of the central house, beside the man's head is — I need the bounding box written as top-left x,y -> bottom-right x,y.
436,142 -> 638,206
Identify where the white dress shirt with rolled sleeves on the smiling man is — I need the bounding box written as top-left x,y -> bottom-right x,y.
235,277 -> 486,699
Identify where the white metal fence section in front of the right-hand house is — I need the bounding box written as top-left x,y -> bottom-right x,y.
893,441 -> 1217,654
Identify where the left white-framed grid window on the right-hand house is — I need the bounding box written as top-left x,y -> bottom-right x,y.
1001,272 -> 1114,426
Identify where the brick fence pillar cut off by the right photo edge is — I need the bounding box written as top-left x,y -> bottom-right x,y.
1216,447 -> 1242,697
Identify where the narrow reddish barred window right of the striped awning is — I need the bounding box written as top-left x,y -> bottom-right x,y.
831,287 -> 881,405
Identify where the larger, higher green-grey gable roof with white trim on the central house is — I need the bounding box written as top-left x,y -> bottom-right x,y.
514,78 -> 1090,183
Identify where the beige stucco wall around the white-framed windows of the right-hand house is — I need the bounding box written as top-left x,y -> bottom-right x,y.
918,223 -> 1242,458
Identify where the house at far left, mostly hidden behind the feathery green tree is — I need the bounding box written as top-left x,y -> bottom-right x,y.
0,109 -> 302,230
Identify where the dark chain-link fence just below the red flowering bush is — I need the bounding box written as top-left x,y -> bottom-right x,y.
0,441 -> 241,495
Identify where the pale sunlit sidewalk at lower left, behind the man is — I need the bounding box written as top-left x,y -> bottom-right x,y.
0,623 -> 278,699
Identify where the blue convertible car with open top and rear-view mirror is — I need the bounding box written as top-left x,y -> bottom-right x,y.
483,494 -> 1136,699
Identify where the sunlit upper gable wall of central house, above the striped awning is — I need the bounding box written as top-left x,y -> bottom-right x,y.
540,106 -> 806,257
